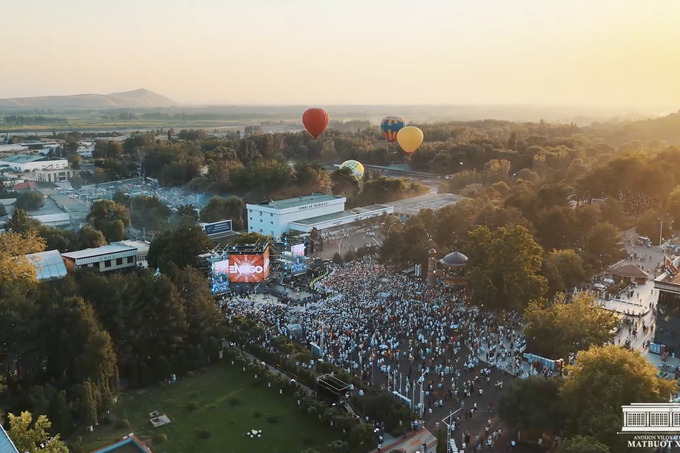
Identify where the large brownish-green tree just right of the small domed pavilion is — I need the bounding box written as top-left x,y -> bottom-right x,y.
465,225 -> 547,310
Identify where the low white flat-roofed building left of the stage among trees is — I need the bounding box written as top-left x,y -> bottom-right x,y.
61,243 -> 137,272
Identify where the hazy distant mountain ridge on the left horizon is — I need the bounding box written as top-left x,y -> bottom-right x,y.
0,88 -> 177,110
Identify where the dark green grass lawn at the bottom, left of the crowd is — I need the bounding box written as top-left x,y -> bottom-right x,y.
83,363 -> 342,453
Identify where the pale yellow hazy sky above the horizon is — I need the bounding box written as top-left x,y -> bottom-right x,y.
0,0 -> 680,108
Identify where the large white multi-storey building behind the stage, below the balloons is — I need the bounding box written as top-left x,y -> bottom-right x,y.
246,194 -> 347,239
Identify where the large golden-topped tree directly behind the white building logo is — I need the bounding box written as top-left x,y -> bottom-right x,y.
560,345 -> 678,451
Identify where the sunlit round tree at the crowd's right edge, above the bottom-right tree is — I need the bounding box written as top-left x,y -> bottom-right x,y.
524,293 -> 620,360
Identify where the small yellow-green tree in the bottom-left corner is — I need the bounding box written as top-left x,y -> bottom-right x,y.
7,411 -> 68,453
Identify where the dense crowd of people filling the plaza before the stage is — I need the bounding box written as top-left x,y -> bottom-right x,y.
224,257 -> 529,450
